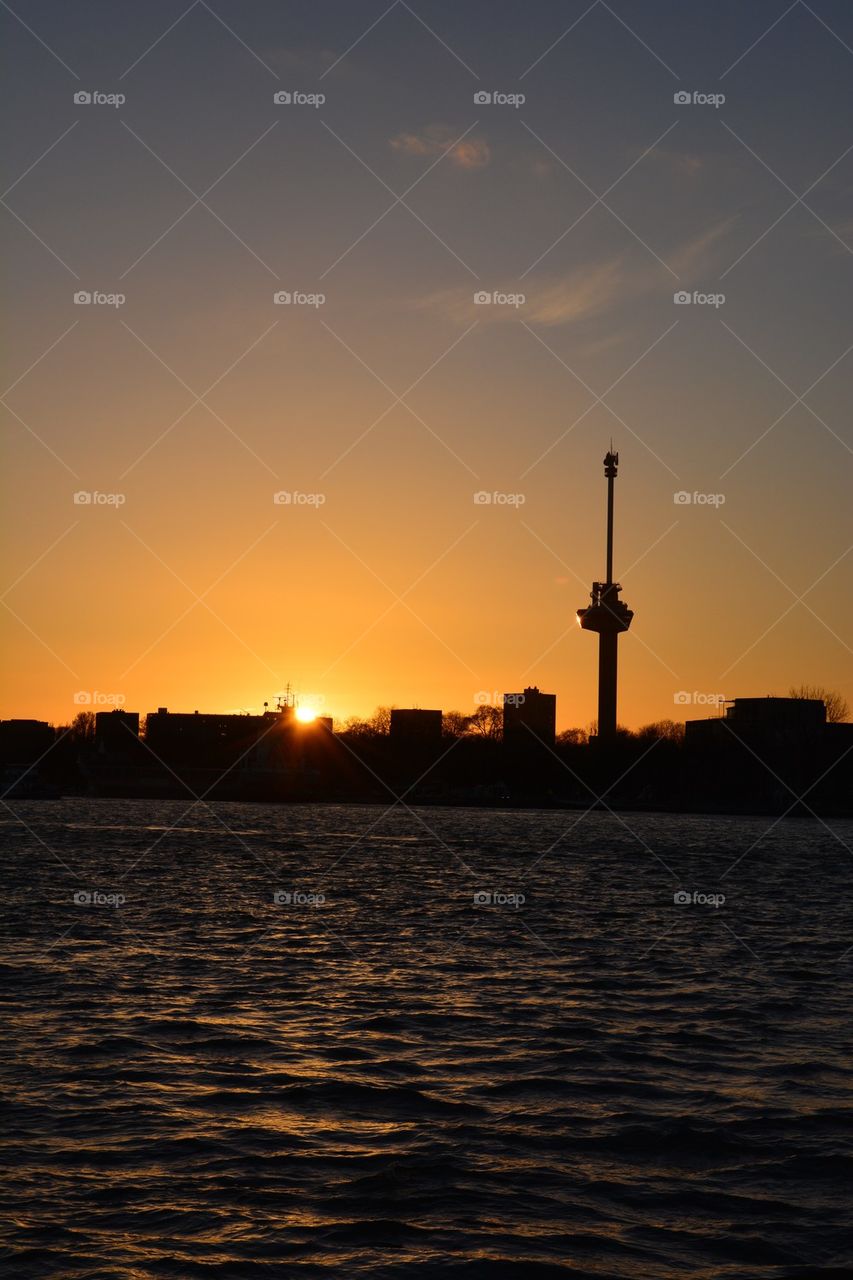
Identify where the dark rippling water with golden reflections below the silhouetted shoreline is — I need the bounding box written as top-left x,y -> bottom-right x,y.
0,800 -> 853,1280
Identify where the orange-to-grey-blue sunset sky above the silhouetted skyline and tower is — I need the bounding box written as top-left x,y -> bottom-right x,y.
0,0 -> 853,728
